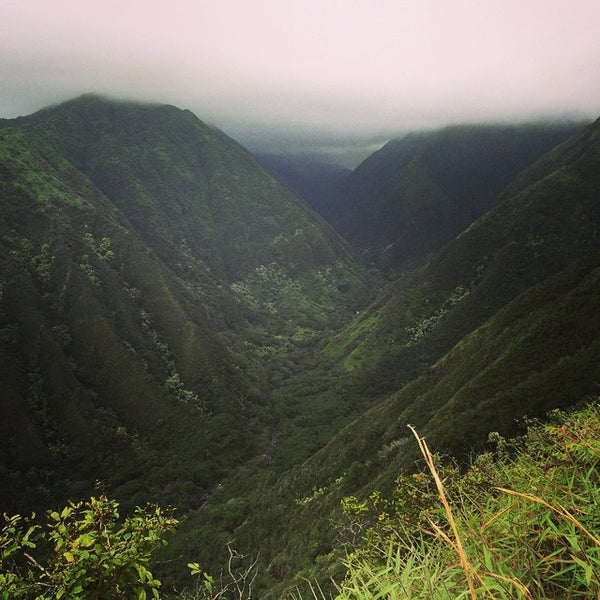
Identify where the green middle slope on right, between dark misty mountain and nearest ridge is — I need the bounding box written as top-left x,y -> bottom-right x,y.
327,119 -> 599,404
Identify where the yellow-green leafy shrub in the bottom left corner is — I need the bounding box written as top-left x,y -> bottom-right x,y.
0,495 -> 177,600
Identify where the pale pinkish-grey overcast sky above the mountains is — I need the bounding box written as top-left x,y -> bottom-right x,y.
0,0 -> 600,162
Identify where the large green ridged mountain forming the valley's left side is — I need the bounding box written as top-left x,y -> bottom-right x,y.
0,96 -> 372,510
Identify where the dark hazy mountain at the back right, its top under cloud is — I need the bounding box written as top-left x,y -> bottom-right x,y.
332,124 -> 582,270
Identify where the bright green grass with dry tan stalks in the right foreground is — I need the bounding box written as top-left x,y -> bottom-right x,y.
305,403 -> 600,600
